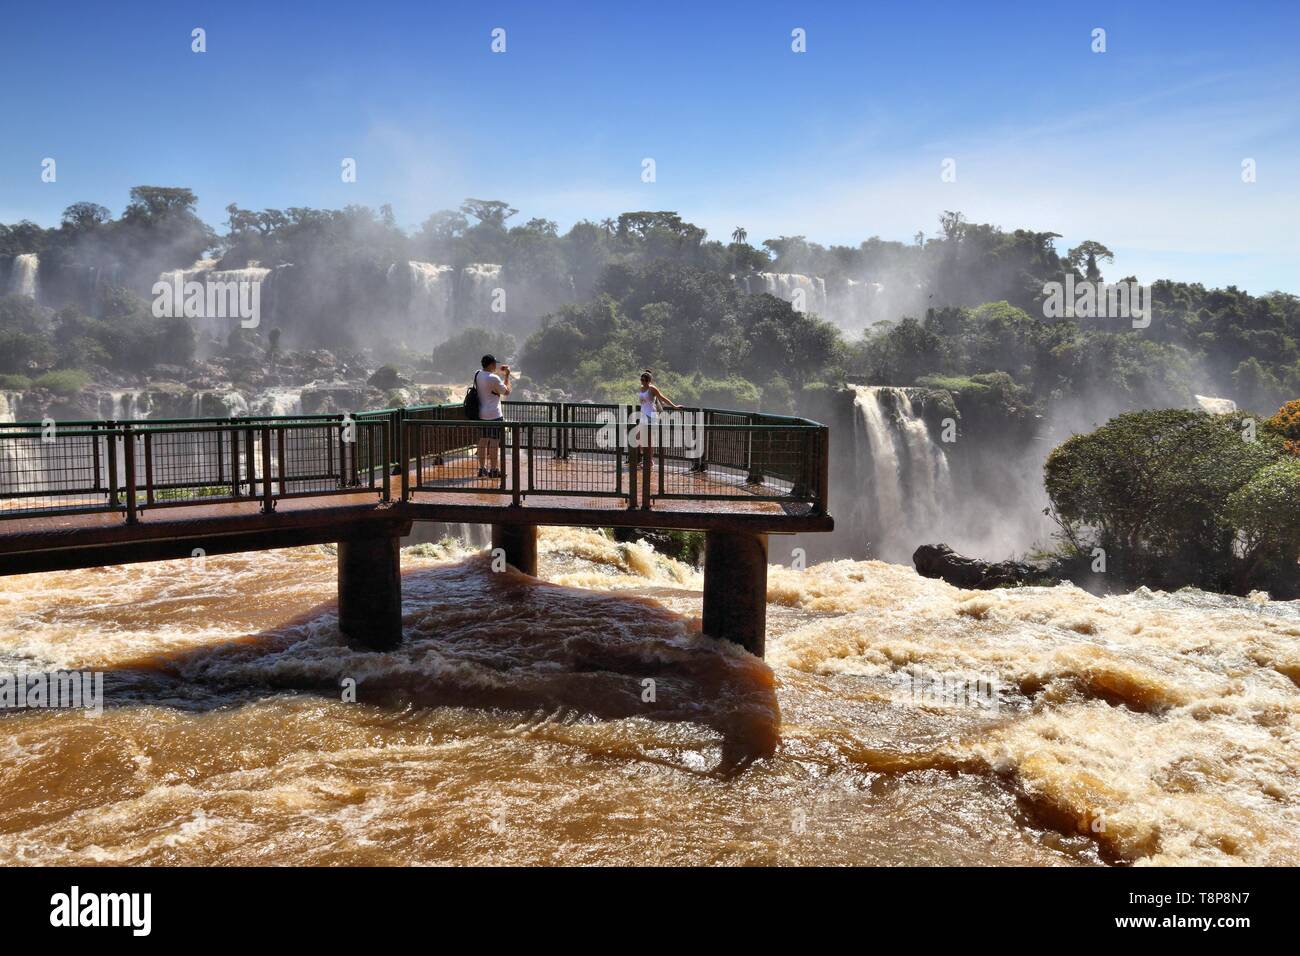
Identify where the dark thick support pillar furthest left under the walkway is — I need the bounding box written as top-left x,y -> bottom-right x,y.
338,535 -> 402,650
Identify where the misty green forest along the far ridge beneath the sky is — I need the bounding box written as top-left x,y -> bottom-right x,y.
0,186 -> 1300,414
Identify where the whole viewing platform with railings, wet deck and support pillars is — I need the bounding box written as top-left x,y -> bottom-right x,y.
0,402 -> 833,654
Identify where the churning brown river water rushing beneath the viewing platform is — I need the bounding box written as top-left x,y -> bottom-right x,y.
0,529 -> 1300,865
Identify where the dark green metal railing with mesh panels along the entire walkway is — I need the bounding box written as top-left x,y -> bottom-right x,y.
0,402 -> 828,522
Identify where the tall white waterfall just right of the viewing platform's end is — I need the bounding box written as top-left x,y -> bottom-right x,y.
849,385 -> 954,562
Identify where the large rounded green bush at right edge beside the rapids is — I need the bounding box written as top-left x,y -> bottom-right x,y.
1044,401 -> 1300,598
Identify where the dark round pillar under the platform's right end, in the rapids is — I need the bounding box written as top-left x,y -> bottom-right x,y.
705,531 -> 767,657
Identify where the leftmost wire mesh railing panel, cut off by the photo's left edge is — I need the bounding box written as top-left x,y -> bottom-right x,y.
0,424 -> 120,516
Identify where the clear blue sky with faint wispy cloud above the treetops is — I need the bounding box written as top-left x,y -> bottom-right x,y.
0,0 -> 1300,293
